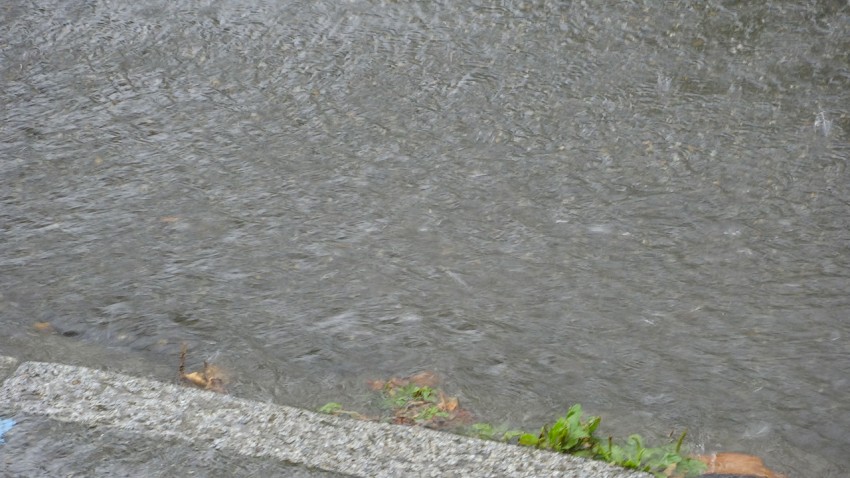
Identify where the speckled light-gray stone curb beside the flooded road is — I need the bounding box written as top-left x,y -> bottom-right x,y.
0,356 -> 650,478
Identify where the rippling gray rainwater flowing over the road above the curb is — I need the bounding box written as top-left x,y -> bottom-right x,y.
0,0 -> 850,476
